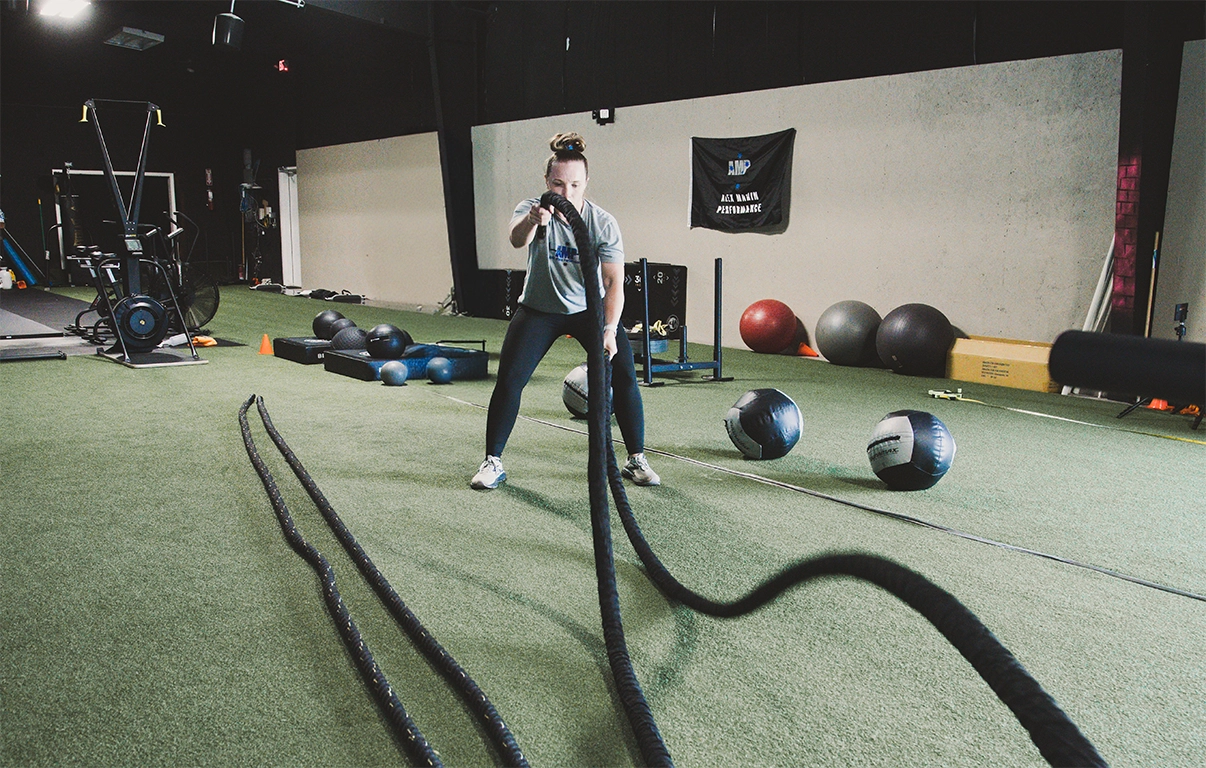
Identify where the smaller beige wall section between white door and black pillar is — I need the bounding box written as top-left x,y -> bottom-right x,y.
297,133 -> 452,305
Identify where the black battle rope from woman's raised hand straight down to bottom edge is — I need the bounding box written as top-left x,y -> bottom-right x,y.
540,192 -> 674,766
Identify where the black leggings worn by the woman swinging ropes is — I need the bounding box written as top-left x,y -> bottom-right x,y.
486,304 -> 645,456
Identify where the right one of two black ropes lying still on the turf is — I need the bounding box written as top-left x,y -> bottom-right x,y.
256,398 -> 528,768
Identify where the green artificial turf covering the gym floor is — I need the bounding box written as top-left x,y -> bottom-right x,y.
0,287 -> 1206,767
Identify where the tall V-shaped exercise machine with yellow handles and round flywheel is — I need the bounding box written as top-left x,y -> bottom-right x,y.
69,99 -> 217,368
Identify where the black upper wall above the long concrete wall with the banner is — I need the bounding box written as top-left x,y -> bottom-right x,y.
480,1 -> 1143,123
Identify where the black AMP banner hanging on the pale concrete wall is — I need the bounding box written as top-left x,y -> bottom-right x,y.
691,128 -> 796,231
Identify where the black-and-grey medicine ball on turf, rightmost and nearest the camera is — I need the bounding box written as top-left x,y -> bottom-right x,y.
867,411 -> 955,491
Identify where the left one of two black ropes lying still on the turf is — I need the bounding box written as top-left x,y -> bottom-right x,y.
239,395 -> 443,766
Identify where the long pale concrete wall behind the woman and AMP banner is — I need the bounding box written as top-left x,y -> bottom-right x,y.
473,51 -> 1119,347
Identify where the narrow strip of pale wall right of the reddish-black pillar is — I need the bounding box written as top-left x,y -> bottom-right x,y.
1152,40 -> 1206,341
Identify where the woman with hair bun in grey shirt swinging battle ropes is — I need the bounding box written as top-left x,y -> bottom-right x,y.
469,133 -> 661,489
